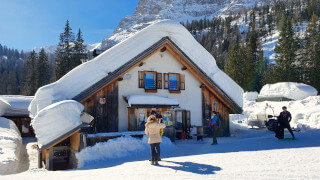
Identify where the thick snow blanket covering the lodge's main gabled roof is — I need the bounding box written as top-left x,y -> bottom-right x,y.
29,20 -> 243,117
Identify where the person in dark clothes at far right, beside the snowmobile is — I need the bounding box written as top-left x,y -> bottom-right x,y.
277,106 -> 295,139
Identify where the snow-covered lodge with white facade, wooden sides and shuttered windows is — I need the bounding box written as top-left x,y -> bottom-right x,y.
30,21 -> 243,170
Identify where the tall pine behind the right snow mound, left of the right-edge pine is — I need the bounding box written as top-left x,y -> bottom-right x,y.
273,15 -> 299,82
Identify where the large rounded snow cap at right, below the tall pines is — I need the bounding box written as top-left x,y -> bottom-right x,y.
259,82 -> 318,100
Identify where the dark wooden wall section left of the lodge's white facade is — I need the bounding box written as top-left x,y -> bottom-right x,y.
82,80 -> 118,132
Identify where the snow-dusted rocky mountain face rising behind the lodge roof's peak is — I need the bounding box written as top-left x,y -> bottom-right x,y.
100,0 -> 264,49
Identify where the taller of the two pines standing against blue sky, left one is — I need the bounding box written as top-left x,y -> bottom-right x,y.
55,20 -> 74,80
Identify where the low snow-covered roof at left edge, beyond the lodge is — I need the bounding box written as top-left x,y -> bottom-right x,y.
0,95 -> 33,116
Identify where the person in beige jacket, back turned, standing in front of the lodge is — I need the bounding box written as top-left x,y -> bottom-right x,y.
145,113 -> 166,165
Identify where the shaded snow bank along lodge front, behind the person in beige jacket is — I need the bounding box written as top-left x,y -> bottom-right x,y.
76,136 -> 177,168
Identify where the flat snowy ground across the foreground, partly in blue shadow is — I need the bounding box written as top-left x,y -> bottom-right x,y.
0,130 -> 320,180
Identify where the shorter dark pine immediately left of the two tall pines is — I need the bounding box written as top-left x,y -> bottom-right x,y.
35,48 -> 50,88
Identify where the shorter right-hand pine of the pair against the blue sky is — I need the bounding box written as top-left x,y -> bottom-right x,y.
72,29 -> 88,67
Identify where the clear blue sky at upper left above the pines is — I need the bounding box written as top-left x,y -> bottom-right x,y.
0,0 -> 139,49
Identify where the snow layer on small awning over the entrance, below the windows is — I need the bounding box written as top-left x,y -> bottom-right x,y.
124,94 -> 179,108
